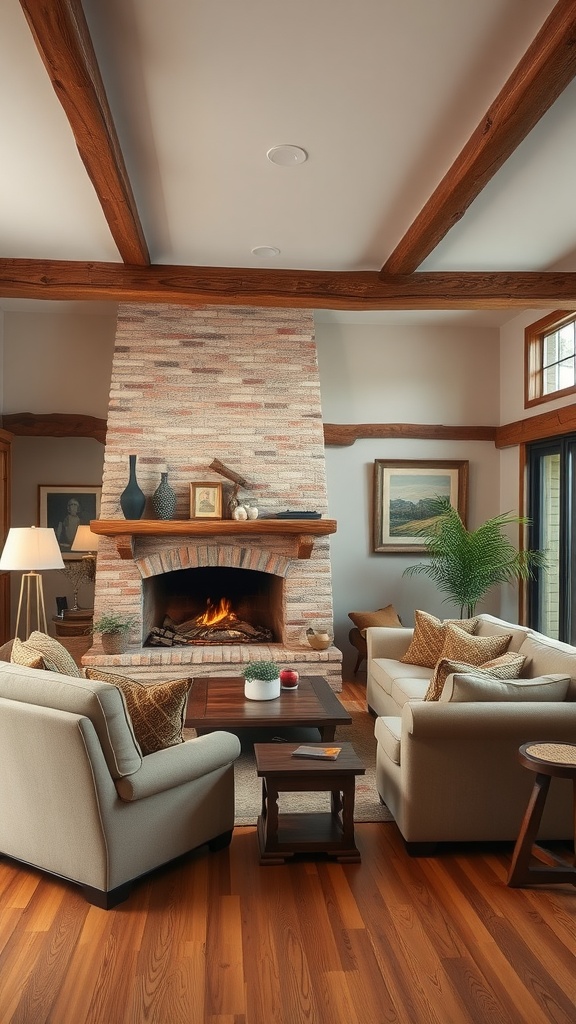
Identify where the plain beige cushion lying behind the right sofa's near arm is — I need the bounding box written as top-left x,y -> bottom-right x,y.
440,673 -> 570,703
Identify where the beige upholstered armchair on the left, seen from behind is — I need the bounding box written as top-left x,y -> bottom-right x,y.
0,663 -> 240,909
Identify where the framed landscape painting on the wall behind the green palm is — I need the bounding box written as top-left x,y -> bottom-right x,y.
373,459 -> 468,553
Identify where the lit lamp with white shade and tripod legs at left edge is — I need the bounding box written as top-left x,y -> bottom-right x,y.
0,526 -> 64,640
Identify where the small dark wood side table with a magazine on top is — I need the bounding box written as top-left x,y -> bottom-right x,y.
254,743 -> 366,864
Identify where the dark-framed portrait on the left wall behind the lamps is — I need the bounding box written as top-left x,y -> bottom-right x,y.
38,483 -> 102,559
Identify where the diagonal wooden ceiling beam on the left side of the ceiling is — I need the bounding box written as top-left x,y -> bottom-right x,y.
20,0 -> 150,266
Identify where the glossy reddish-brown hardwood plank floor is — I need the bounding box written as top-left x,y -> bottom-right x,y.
0,685 -> 576,1024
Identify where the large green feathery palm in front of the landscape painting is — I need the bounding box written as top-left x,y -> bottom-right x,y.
403,498 -> 546,618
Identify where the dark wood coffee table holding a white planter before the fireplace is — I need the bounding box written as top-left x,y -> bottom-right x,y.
184,676 -> 352,743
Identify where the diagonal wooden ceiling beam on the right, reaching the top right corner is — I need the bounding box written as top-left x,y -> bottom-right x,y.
382,0 -> 576,274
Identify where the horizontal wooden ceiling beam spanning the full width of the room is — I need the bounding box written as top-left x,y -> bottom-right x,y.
0,259 -> 576,310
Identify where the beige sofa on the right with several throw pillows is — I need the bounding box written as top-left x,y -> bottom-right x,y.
366,614 -> 576,853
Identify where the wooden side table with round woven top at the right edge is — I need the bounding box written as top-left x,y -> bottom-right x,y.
507,741 -> 576,887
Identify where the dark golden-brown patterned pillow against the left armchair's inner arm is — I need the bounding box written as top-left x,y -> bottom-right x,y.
86,668 -> 192,755
